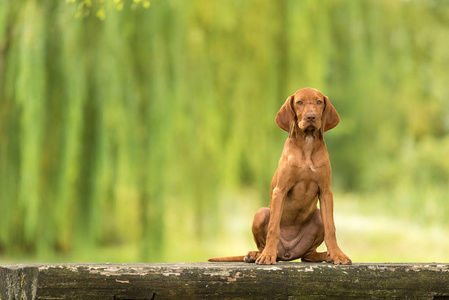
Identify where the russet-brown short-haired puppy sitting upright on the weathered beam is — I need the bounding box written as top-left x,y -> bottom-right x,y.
209,88 -> 352,264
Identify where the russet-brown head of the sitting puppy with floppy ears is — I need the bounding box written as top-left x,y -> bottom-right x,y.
276,88 -> 340,133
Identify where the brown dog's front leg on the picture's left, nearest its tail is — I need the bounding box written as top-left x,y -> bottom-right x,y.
256,187 -> 287,265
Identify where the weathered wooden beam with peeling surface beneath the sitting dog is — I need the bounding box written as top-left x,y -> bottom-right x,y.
0,262 -> 449,300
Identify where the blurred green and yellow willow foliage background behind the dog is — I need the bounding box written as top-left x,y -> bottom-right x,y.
0,0 -> 449,263
